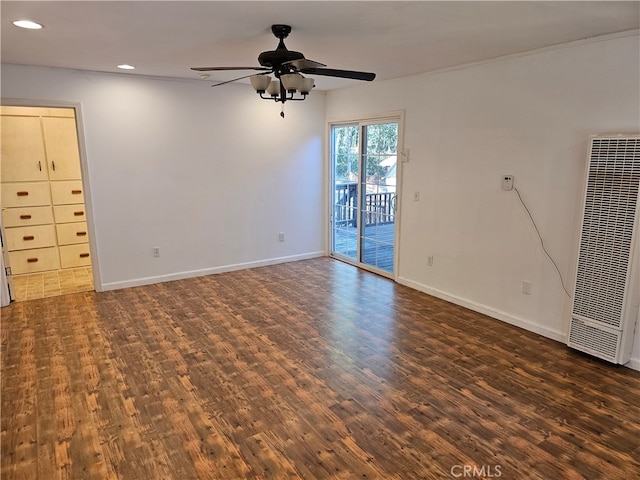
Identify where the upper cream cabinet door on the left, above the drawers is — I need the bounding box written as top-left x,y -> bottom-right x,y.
0,115 -> 48,182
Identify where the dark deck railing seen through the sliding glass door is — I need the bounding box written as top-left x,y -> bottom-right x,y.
333,182 -> 396,227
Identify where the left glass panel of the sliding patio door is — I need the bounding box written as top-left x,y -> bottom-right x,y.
331,125 -> 359,260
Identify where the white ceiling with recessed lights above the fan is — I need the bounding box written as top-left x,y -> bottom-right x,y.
0,0 -> 640,90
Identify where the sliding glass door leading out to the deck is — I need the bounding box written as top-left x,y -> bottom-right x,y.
330,120 -> 398,276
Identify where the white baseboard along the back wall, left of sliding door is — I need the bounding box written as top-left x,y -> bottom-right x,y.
96,252 -> 325,291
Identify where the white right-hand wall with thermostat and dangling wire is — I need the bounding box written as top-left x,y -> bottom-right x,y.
326,35 -> 640,369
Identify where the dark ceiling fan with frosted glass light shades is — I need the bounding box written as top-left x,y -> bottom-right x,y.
191,25 -> 376,117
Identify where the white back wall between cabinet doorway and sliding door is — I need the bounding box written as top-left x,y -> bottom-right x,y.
2,65 -> 325,289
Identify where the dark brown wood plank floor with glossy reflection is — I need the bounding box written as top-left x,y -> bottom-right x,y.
2,258 -> 640,480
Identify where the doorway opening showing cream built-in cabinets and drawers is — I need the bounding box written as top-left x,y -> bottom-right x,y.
0,106 -> 94,301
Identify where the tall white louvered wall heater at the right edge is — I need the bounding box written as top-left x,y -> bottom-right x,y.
569,136 -> 640,361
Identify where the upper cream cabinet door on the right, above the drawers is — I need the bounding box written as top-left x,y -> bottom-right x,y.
42,117 -> 82,180
